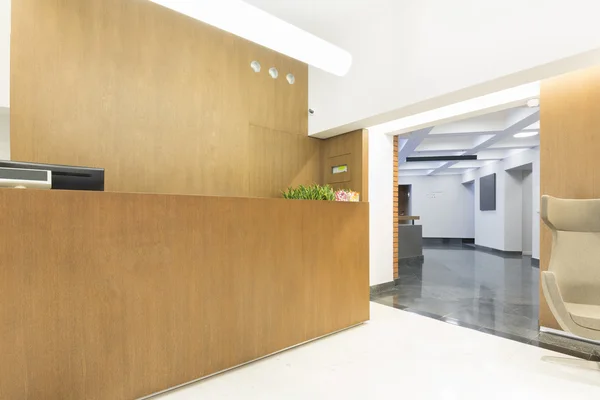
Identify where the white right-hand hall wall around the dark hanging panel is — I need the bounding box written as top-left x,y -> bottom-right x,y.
463,148 -> 540,253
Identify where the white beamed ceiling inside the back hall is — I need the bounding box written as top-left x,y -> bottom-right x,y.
398,107 -> 540,176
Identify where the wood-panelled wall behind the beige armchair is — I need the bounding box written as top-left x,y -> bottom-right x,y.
540,67 -> 600,329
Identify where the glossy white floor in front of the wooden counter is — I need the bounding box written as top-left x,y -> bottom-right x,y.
156,303 -> 600,400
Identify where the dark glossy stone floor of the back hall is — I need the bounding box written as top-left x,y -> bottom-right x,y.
372,244 -> 597,359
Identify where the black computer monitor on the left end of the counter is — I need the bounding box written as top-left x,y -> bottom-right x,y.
0,160 -> 104,191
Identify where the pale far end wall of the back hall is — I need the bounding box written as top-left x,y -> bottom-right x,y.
398,175 -> 474,238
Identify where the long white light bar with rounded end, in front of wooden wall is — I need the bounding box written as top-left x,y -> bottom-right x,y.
150,0 -> 352,76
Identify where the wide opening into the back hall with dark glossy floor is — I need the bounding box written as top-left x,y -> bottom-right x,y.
384,106 -> 540,342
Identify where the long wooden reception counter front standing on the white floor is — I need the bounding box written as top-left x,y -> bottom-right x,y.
0,189 -> 369,400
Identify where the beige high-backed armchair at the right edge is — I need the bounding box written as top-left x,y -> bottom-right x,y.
541,196 -> 600,340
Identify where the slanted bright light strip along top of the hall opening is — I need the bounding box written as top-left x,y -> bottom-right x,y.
368,82 -> 540,134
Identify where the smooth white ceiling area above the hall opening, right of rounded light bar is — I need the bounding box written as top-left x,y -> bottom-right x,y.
241,0 -> 600,138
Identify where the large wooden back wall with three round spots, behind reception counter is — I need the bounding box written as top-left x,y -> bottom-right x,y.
11,0 -> 320,196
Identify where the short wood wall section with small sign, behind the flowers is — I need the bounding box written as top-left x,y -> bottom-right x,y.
321,129 -> 369,201
